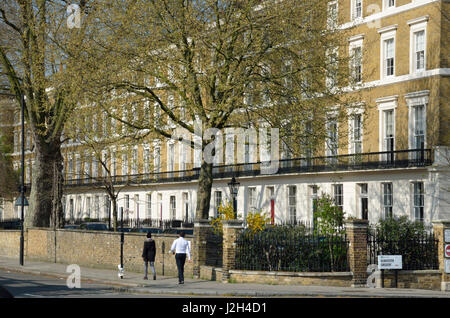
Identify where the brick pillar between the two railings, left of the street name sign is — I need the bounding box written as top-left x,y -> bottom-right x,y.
345,220 -> 369,287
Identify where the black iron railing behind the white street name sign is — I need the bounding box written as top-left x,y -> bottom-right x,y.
367,232 -> 439,270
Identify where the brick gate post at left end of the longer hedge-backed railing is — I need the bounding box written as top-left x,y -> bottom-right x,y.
222,220 -> 243,283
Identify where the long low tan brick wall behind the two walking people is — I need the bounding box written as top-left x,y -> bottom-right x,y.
0,228 -> 193,277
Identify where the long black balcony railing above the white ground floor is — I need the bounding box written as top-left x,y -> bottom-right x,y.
65,149 -> 432,187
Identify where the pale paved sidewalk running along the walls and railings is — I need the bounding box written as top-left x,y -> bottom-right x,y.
0,256 -> 450,298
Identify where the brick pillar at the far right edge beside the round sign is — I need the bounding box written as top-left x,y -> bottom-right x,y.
432,220 -> 450,291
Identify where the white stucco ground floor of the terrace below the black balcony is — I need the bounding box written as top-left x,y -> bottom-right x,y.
59,166 -> 450,224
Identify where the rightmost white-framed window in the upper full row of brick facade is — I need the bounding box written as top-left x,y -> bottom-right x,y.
407,16 -> 428,74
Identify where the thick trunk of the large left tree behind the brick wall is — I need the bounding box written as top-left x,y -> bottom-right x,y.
24,135 -> 64,227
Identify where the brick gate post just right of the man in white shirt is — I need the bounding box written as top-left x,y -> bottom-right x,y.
192,219 -> 212,278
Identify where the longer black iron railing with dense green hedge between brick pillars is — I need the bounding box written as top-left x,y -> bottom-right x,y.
235,231 -> 349,272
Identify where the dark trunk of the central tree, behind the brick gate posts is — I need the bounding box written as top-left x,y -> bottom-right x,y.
195,159 -> 213,220
